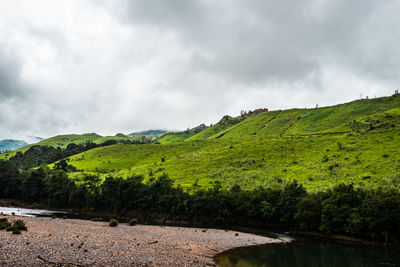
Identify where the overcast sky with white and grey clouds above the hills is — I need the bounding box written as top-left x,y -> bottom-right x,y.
0,0 -> 400,141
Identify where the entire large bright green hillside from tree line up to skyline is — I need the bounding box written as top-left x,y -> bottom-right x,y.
67,95 -> 400,190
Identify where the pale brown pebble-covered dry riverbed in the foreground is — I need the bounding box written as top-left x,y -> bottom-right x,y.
0,216 -> 281,266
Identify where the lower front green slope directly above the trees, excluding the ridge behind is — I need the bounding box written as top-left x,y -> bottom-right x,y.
70,130 -> 400,193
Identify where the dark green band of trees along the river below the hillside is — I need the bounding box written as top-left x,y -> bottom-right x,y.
0,161 -> 400,246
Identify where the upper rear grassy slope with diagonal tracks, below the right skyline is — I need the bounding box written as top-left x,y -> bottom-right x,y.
161,94 -> 400,143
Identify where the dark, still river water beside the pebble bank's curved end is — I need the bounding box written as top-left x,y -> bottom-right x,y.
215,240 -> 400,267
